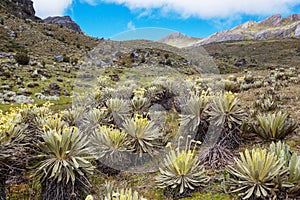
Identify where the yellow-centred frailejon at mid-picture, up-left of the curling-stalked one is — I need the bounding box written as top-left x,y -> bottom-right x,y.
122,115 -> 163,157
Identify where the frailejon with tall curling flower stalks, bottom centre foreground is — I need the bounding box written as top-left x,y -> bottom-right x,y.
155,137 -> 208,195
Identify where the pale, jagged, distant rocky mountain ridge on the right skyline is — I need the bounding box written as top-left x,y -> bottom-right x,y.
159,14 -> 300,47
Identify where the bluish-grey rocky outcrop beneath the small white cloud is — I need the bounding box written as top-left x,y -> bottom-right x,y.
44,16 -> 83,33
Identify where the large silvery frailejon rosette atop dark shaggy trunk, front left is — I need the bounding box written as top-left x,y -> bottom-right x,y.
35,127 -> 94,184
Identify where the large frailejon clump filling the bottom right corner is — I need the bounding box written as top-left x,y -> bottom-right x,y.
227,141 -> 300,199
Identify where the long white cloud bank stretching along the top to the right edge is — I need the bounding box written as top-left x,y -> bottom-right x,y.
81,0 -> 299,19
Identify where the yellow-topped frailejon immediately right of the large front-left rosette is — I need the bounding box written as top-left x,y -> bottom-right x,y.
91,126 -> 130,175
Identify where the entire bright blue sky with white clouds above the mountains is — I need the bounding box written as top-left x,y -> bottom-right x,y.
33,0 -> 300,40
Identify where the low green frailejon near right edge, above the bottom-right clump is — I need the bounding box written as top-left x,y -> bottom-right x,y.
253,111 -> 297,141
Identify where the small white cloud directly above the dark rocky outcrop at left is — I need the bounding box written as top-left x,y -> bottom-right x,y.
32,0 -> 72,18
